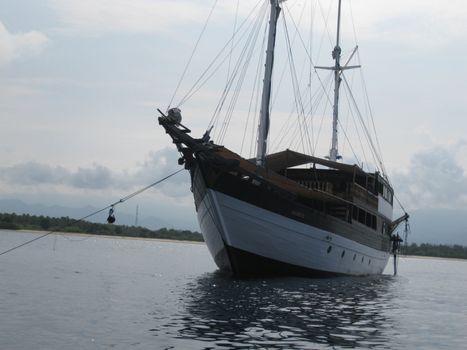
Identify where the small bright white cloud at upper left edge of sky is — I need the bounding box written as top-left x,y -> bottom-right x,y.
0,21 -> 49,65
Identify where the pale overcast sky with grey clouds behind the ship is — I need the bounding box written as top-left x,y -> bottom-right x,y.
0,0 -> 467,245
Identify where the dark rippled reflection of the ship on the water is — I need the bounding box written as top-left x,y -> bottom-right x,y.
177,272 -> 397,349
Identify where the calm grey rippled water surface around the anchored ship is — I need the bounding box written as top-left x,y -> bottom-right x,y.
0,231 -> 467,350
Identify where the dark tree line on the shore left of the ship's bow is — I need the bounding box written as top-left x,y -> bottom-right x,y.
0,213 -> 203,242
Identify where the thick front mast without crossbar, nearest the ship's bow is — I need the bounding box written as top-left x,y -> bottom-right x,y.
256,0 -> 282,167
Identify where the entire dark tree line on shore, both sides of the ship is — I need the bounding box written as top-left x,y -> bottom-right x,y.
0,213 -> 467,259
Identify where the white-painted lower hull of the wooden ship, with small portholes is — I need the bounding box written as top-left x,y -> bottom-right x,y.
198,189 -> 389,275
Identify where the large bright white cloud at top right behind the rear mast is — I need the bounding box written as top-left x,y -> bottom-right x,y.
283,0 -> 467,49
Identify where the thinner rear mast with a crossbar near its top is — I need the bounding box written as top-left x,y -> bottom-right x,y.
329,0 -> 342,162
